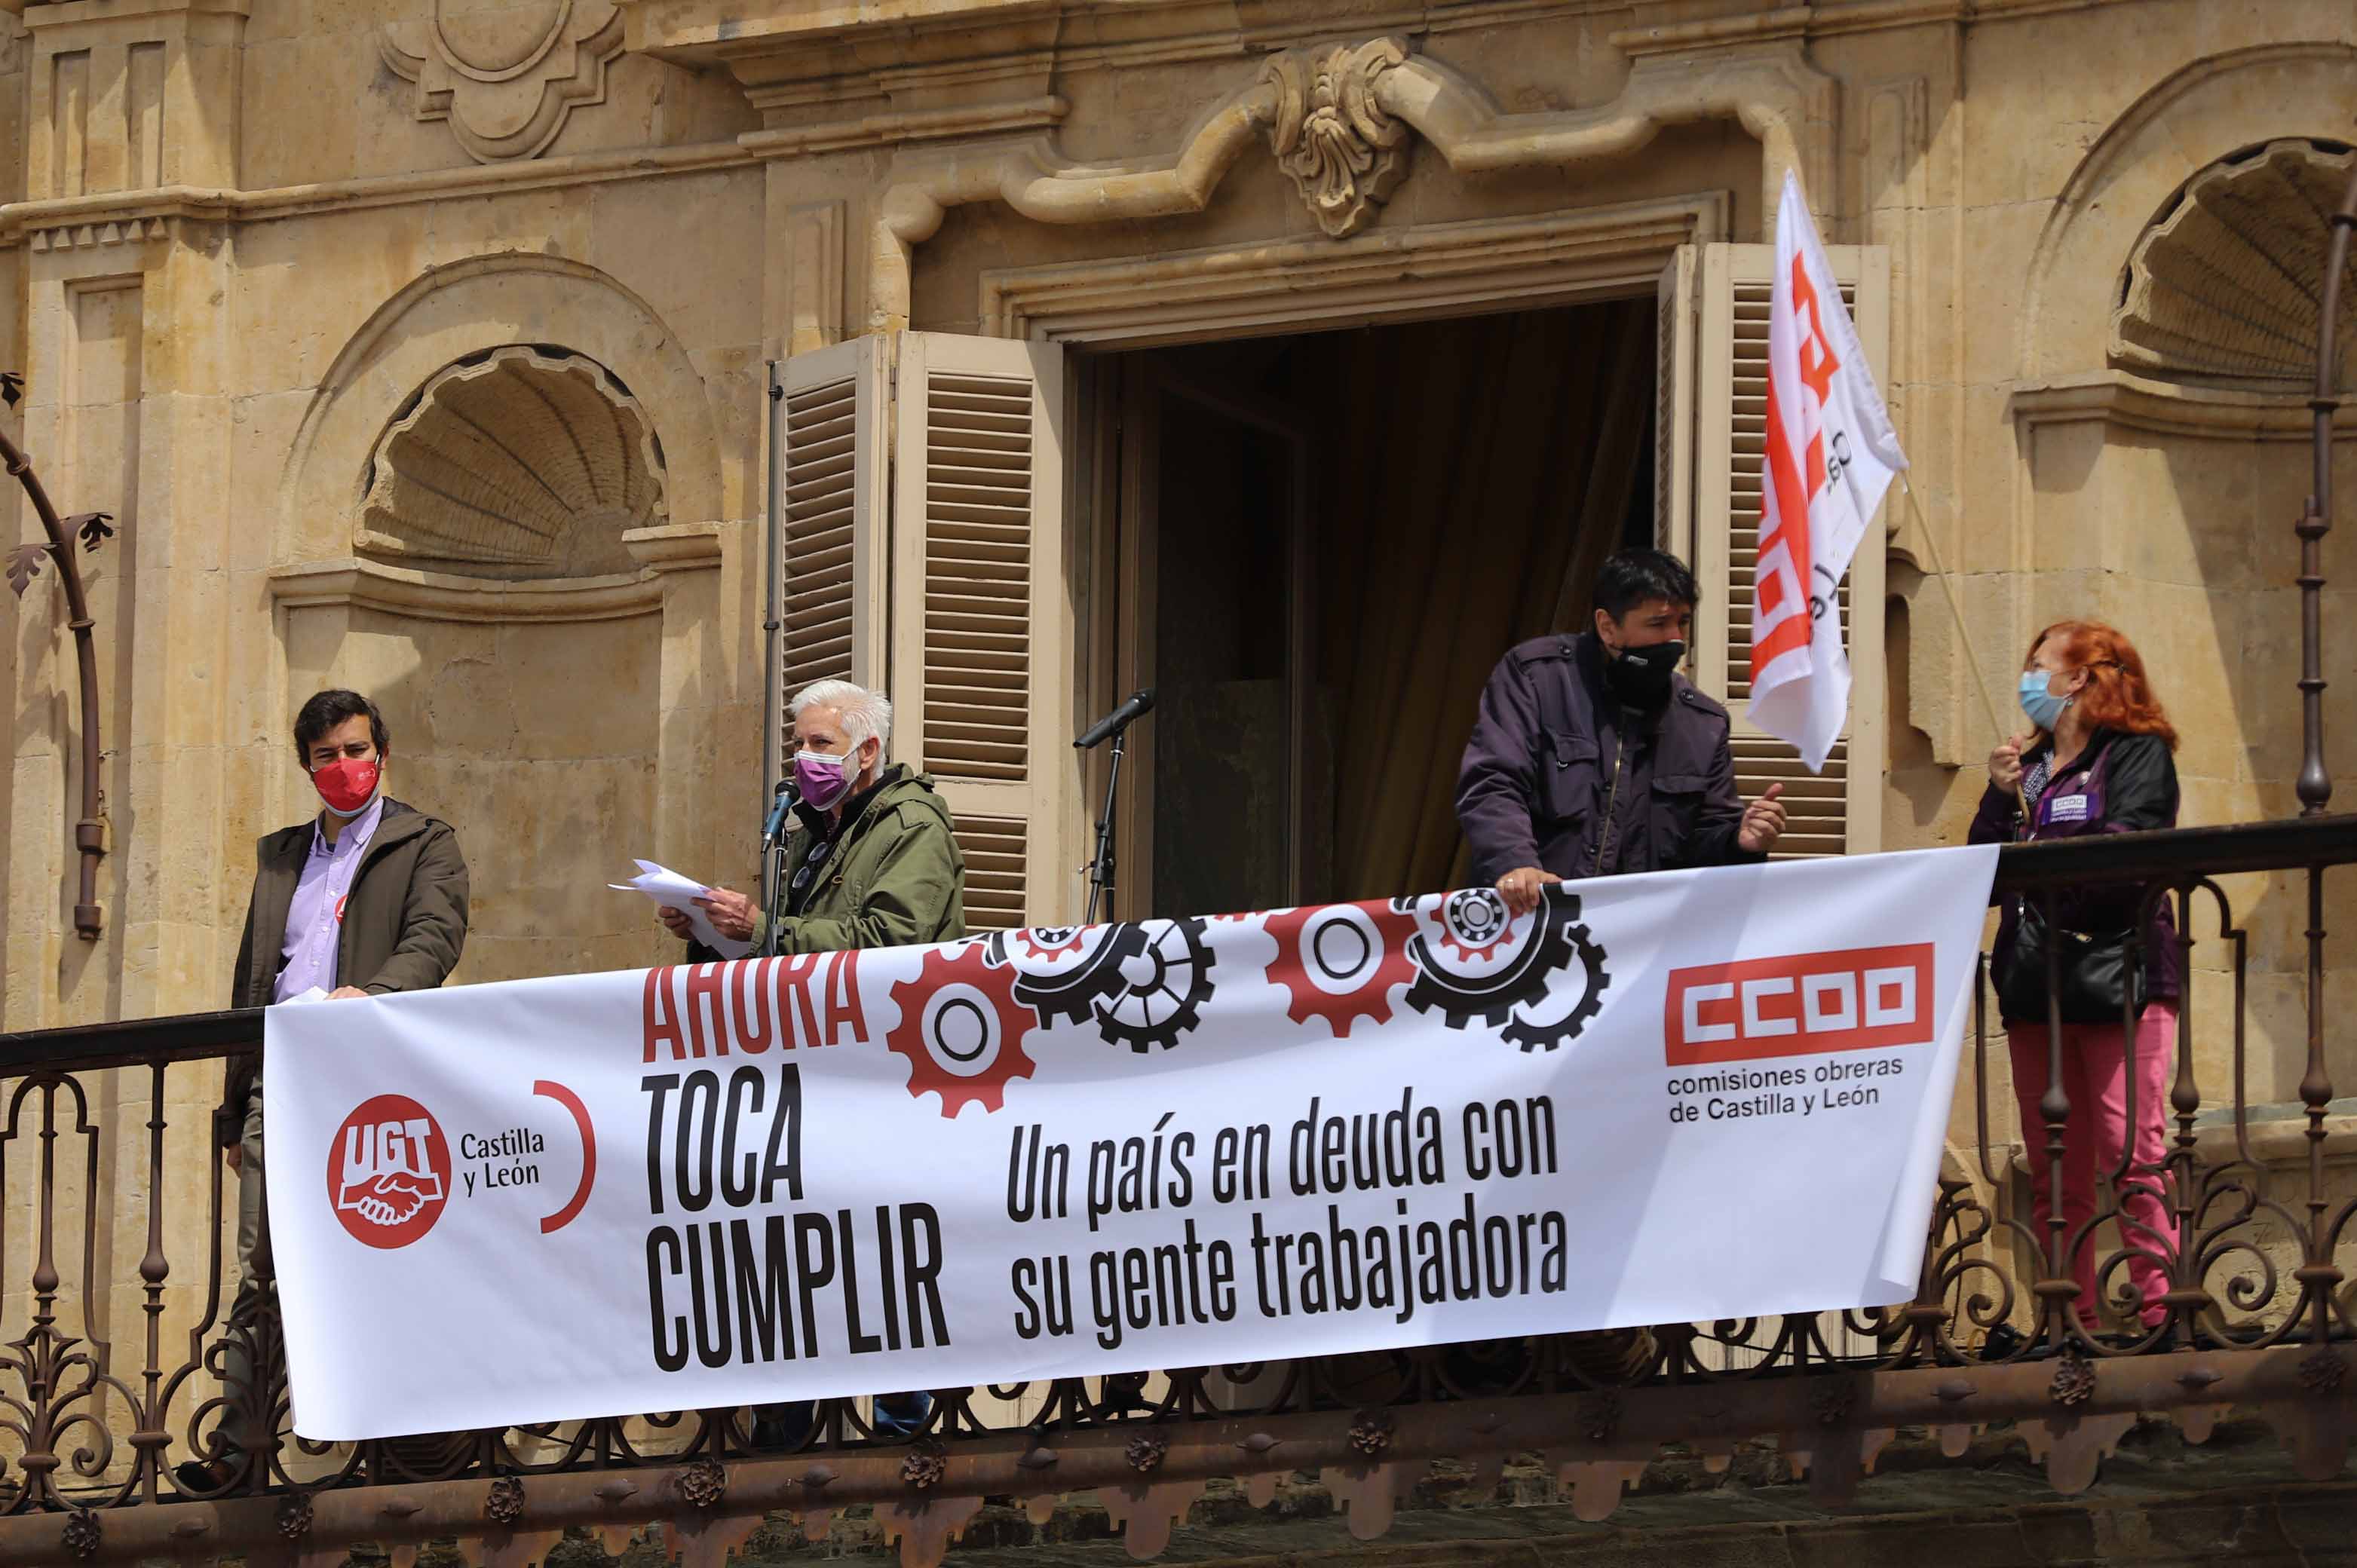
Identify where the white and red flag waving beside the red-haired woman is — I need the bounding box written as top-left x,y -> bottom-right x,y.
1752,172 -> 1907,773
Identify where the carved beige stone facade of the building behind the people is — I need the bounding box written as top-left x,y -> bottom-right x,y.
0,0 -> 2357,1358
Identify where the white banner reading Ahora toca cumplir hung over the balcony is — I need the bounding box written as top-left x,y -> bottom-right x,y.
264,849 -> 1997,1441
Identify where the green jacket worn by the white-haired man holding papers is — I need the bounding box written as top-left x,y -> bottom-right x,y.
752,761 -> 967,953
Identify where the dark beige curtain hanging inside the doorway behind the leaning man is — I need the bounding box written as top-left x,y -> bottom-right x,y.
1317,299 -> 1654,899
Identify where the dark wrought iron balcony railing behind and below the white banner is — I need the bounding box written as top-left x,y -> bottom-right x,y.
0,816 -> 2357,1563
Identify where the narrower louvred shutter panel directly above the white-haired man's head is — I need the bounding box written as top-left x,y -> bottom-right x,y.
766,337 -> 891,778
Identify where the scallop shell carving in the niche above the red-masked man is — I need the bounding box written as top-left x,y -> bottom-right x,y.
356,345 -> 662,577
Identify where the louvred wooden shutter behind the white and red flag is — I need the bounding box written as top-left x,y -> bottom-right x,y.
1692,245 -> 1890,856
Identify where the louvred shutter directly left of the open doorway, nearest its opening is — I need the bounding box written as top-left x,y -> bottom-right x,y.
891,332 -> 1074,929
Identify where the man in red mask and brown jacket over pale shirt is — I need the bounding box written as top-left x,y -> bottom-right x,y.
179,691 -> 467,1490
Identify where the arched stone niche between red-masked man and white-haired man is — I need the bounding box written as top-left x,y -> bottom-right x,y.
266,257 -> 743,981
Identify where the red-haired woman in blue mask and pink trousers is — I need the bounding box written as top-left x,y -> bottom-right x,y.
1972,620 -> 2183,1332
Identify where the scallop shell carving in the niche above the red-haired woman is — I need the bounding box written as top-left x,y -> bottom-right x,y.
2112,139 -> 2357,389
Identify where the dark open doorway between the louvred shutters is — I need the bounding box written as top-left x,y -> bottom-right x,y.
1099,297 -> 1657,917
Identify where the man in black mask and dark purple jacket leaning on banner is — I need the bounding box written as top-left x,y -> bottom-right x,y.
1457,550 -> 1784,915
